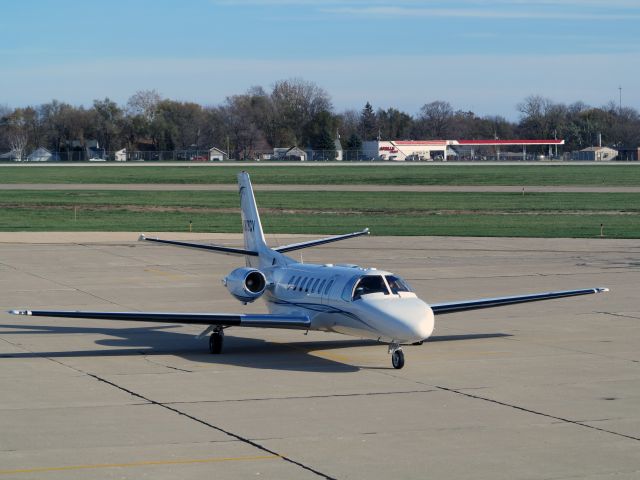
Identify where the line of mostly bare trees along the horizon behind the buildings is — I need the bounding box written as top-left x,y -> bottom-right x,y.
0,79 -> 640,159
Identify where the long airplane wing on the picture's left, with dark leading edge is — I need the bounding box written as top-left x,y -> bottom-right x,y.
9,310 -> 311,330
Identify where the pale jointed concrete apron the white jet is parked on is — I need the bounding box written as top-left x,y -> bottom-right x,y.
0,233 -> 640,480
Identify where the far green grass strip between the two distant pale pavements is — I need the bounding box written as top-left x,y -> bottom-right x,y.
0,163 -> 640,186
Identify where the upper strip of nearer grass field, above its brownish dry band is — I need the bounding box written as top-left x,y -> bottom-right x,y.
0,190 -> 640,214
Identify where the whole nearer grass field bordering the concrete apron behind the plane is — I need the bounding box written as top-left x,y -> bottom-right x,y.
0,190 -> 640,238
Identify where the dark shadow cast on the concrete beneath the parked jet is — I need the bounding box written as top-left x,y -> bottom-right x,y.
0,324 -> 510,373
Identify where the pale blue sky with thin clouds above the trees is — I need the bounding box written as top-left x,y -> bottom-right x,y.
0,0 -> 640,120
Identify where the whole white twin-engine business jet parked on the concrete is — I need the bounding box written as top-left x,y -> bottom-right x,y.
9,171 -> 609,369
